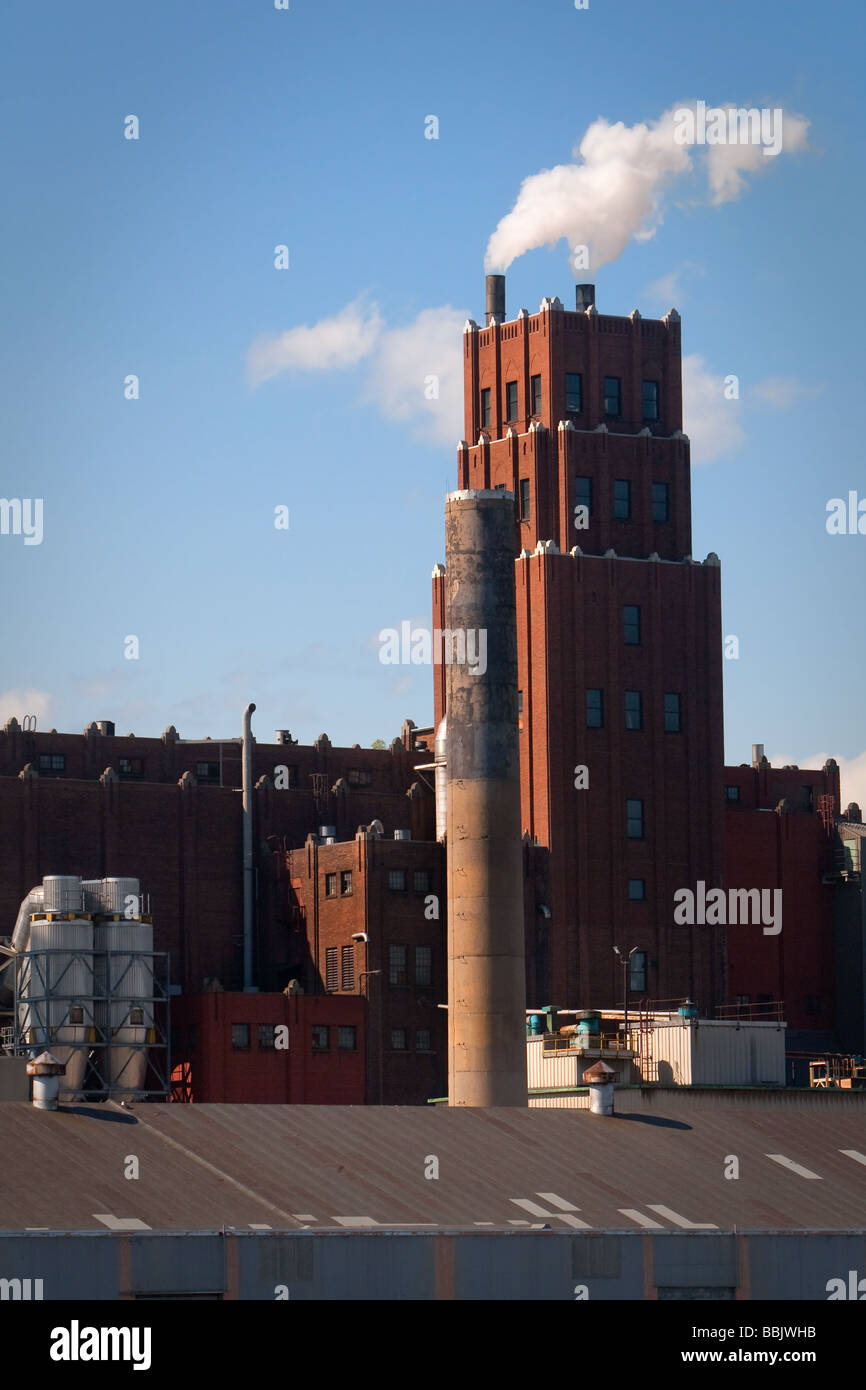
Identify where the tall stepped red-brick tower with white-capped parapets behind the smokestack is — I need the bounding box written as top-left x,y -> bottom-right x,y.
434,275 -> 724,1011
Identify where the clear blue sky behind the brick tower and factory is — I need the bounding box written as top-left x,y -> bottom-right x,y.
0,0 -> 866,796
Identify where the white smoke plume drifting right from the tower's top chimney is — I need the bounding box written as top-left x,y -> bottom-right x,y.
485,101 -> 809,271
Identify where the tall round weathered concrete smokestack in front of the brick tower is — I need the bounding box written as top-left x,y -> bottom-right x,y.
443,491 -> 527,1105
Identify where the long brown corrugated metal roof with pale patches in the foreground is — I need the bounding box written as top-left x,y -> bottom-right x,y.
0,1091 -> 866,1230
